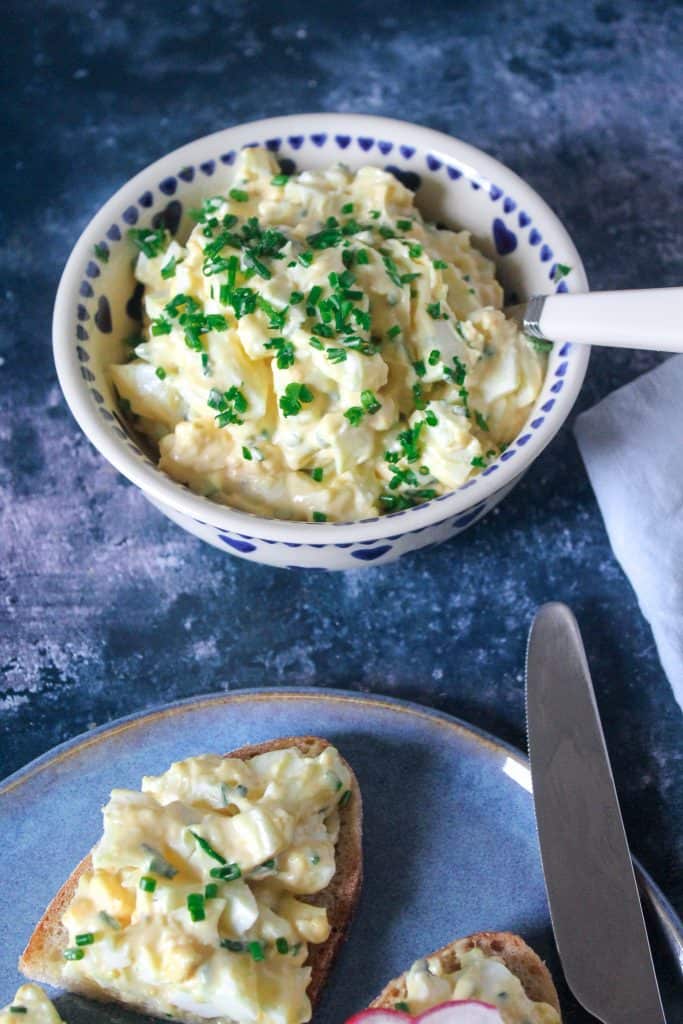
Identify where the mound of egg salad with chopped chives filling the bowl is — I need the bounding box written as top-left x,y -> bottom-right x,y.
111,148 -> 546,522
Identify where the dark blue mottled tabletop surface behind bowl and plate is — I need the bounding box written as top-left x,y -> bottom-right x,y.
0,0 -> 683,966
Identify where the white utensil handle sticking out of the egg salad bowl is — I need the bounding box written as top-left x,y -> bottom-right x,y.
524,288 -> 683,352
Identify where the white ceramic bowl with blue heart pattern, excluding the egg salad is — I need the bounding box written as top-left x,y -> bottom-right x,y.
53,114 -> 589,569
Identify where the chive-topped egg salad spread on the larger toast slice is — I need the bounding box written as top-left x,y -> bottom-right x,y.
58,746 -> 351,1024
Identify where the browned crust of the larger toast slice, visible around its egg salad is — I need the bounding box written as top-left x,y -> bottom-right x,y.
18,736 -> 362,1024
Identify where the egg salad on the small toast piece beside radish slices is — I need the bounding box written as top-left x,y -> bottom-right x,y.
401,947 -> 560,1024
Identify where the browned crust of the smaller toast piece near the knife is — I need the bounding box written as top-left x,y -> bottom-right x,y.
370,932 -> 560,1014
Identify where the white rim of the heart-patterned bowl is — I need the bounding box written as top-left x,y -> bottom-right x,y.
52,112 -> 590,546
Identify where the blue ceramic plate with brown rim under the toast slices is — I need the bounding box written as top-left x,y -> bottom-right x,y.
0,689 -> 683,1024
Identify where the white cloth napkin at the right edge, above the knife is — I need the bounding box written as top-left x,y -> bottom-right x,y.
574,355 -> 683,708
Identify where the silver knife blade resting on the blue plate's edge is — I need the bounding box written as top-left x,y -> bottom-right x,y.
526,602 -> 666,1024
